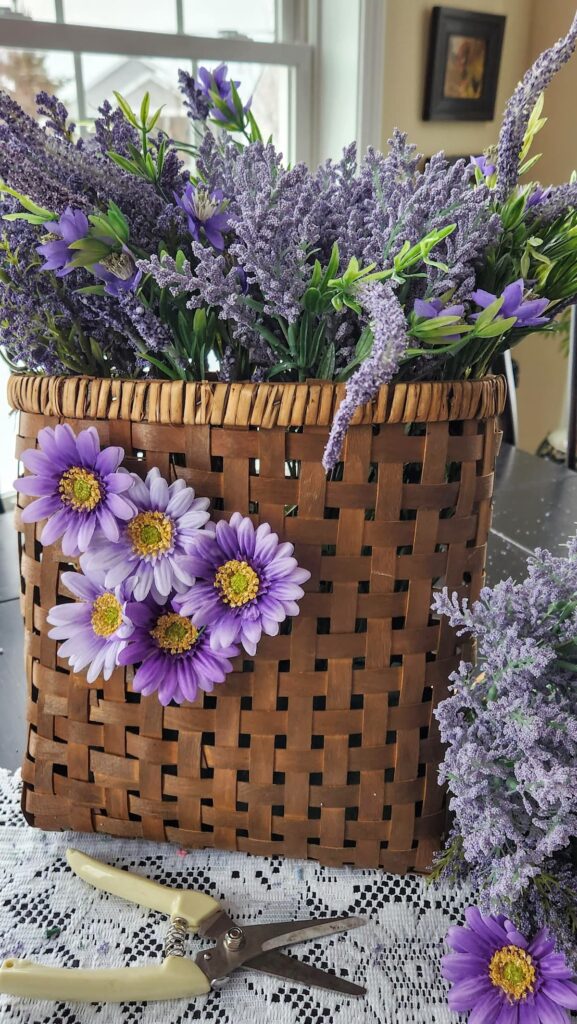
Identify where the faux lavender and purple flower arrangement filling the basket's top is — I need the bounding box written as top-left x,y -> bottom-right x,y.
0,17 -> 577,470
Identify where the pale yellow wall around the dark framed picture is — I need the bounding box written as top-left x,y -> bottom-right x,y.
382,0 -> 577,451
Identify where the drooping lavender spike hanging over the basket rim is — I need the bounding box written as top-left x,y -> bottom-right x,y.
323,283 -> 408,470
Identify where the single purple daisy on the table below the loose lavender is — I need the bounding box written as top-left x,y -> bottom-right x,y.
442,906 -> 577,1024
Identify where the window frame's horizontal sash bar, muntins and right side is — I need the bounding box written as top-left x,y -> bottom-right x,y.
0,0 -> 314,163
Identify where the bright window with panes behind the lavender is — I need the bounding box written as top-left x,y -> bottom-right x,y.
0,0 -> 313,161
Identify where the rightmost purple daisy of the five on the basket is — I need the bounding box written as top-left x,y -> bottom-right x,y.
176,512 -> 311,654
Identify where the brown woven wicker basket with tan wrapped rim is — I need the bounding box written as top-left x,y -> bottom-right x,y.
9,376 -> 505,872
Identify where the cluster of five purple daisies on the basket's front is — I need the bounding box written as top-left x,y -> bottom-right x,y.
14,424 -> 311,705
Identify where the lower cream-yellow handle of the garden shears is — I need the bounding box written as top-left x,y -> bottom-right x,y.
0,956 -> 210,1002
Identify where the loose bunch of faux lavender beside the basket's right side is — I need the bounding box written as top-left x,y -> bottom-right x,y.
434,539 -> 577,957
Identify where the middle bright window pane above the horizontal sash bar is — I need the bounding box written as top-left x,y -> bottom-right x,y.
64,0 -> 176,32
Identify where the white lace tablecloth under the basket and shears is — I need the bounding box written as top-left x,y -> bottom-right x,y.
0,769 -> 467,1024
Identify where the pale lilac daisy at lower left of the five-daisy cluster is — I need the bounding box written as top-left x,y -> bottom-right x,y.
47,559 -> 132,683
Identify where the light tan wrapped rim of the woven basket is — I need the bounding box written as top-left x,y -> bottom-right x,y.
8,374 -> 506,429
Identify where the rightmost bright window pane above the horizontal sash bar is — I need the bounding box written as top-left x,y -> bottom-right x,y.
182,0 -> 276,43
